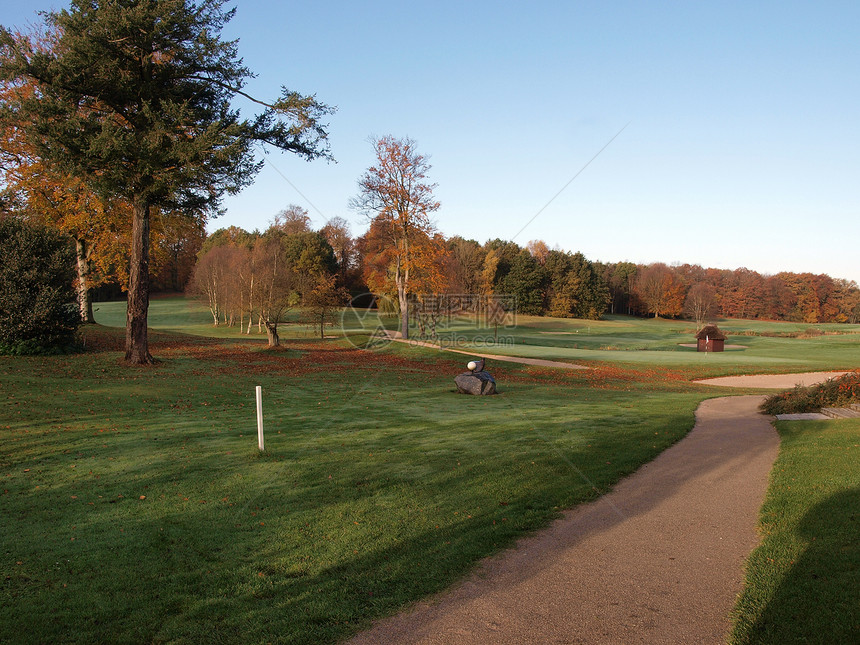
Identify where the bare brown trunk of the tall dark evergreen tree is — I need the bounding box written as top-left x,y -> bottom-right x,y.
125,196 -> 154,365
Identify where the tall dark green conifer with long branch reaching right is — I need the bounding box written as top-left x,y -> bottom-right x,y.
0,0 -> 330,364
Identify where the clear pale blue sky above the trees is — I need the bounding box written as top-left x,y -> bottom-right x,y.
0,0 -> 860,282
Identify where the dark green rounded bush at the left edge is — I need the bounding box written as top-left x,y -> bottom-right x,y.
0,218 -> 81,354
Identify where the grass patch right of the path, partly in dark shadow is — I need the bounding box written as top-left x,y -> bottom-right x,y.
731,419 -> 860,645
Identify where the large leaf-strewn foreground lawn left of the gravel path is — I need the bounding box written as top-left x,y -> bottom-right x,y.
0,299 -> 856,643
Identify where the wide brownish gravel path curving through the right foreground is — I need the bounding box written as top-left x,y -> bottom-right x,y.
349,375 -> 831,645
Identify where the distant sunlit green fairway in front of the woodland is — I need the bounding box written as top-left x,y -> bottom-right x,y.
96,296 -> 860,378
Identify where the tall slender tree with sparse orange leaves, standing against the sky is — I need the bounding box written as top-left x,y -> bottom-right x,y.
350,135 -> 439,338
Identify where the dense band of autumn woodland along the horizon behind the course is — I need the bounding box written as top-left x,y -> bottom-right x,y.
188,206 -> 860,331
